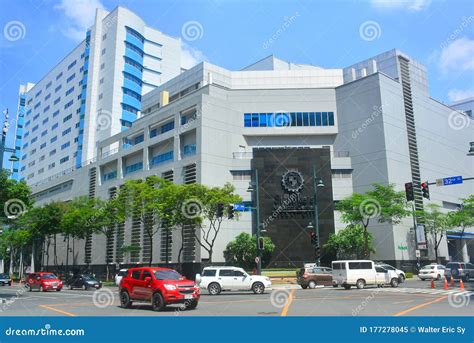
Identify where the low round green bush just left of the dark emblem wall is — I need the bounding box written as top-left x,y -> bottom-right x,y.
224,232 -> 275,270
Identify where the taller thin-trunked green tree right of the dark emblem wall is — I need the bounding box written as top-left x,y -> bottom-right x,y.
336,183 -> 410,258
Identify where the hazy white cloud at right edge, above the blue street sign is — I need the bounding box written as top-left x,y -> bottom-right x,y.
439,38 -> 474,73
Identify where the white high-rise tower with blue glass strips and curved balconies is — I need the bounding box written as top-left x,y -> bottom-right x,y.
12,7 -> 181,184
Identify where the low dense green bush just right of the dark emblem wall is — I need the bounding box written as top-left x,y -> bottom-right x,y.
323,224 -> 375,259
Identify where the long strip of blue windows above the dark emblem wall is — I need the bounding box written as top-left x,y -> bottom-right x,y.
244,112 -> 334,127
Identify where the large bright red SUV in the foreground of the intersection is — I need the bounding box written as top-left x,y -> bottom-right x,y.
120,267 -> 200,311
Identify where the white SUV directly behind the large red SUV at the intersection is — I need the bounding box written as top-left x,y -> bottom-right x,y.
196,267 -> 272,295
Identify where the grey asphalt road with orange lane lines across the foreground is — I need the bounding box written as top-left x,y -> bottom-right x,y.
0,280 -> 474,316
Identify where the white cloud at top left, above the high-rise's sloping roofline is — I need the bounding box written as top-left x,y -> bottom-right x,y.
55,0 -> 104,41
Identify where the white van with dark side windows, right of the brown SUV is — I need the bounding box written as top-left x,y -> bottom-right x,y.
332,260 -> 398,289
